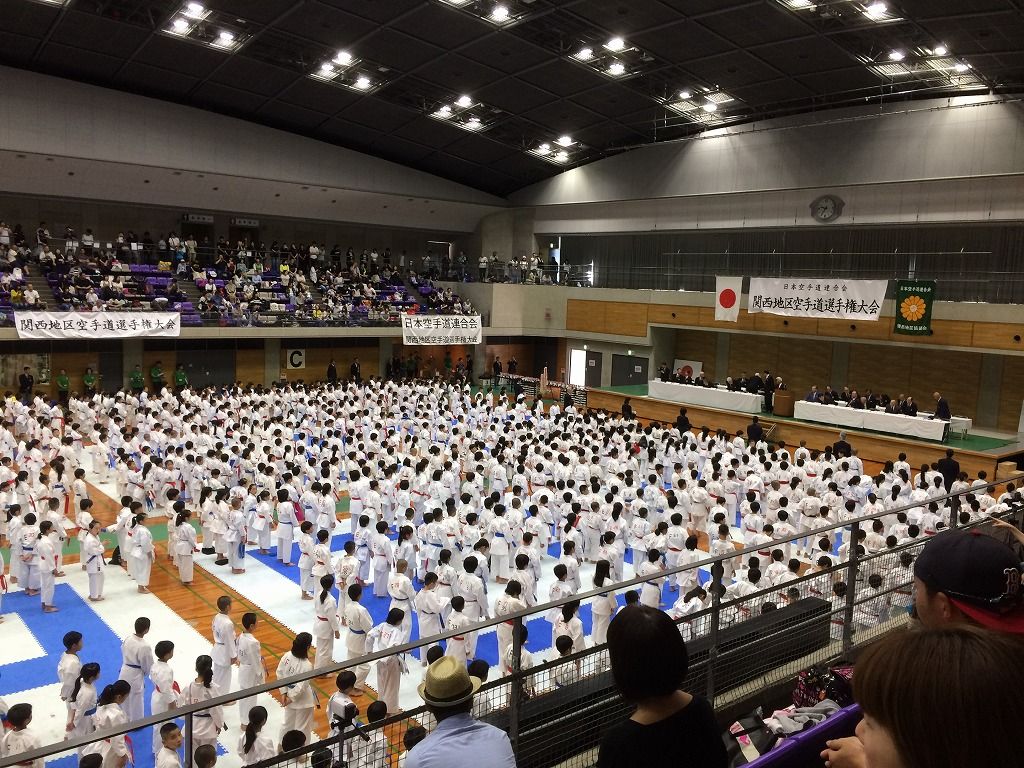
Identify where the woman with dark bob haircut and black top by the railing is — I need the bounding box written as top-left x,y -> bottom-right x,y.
597,605 -> 728,768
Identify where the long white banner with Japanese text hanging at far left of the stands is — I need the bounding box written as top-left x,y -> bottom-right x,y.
14,312 -> 181,339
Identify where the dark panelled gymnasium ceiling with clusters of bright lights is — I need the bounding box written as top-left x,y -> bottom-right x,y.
0,0 -> 1024,196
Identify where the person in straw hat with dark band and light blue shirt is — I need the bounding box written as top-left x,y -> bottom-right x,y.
406,656 -> 516,768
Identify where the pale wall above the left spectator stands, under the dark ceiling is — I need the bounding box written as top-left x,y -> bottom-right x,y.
0,67 -> 506,231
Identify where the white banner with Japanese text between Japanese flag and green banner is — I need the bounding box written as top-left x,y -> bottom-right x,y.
746,278 -> 889,321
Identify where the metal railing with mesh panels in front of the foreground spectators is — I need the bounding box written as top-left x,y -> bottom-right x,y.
0,474 -> 1024,768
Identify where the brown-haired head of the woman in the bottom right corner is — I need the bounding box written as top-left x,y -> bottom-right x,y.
843,625 -> 1024,768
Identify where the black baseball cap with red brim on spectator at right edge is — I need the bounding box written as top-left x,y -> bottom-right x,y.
913,530 -> 1024,635
